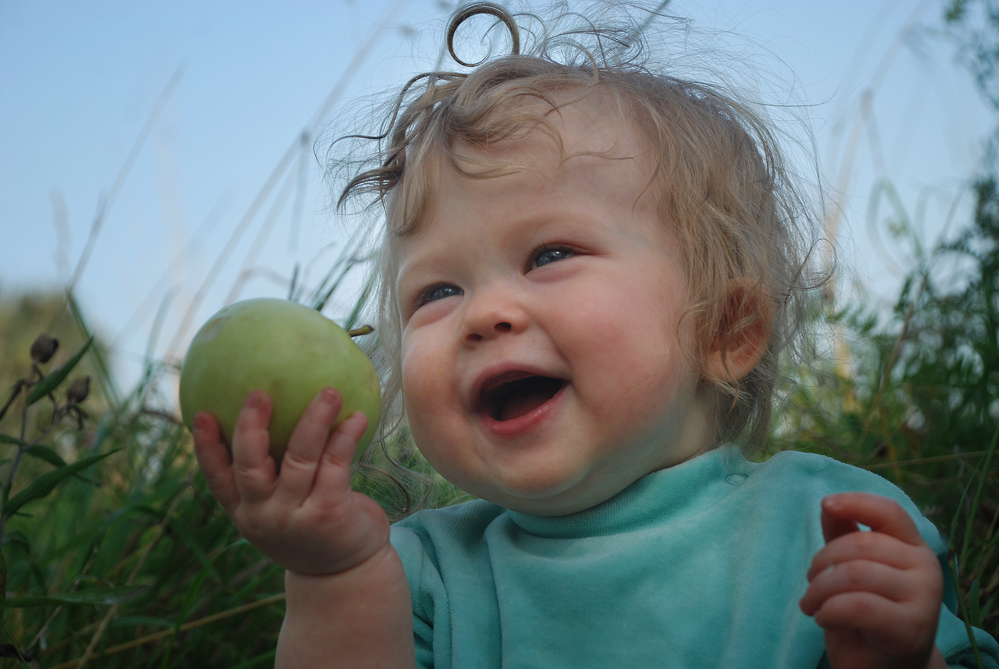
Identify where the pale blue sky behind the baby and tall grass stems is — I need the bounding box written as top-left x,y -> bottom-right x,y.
0,0 -> 993,394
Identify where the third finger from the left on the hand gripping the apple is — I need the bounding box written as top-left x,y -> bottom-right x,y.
275,388 -> 343,505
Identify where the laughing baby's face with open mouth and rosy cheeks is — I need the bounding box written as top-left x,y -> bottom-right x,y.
397,98 -> 709,515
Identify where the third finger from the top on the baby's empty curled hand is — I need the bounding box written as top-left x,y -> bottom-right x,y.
799,560 -> 912,616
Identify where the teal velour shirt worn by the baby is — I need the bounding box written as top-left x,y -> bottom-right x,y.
392,446 -> 999,669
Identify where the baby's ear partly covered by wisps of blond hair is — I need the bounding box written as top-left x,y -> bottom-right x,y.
704,279 -> 774,383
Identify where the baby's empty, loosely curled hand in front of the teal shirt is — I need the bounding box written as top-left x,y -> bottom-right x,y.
800,492 -> 946,669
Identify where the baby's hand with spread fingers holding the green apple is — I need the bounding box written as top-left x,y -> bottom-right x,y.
194,388 -> 389,576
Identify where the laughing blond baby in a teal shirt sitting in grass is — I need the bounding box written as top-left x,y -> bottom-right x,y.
194,3 -> 999,669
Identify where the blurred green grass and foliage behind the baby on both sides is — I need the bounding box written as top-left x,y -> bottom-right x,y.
0,0 -> 999,669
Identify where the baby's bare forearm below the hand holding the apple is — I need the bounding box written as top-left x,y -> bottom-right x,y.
276,545 -> 416,669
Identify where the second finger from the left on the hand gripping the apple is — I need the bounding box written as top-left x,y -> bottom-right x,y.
232,390 -> 277,503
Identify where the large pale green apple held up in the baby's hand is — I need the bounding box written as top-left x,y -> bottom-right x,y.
180,298 -> 381,466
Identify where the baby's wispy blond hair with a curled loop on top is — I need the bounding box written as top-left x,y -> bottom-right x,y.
334,2 -> 821,451
